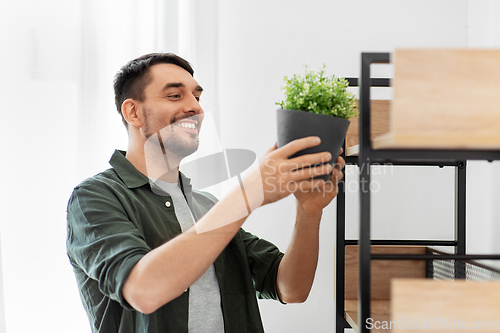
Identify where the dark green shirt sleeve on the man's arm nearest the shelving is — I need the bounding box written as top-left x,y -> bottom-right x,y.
240,229 -> 285,304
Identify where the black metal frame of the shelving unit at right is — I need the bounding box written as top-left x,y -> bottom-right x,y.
335,53 -> 500,333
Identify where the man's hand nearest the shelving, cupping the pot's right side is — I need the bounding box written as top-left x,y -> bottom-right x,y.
293,150 -> 345,214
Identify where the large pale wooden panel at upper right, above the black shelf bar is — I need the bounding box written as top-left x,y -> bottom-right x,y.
376,49 -> 500,150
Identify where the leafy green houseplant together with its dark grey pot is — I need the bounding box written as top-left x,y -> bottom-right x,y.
276,66 -> 357,180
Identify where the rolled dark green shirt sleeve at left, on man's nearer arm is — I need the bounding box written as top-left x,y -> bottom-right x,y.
67,179 -> 150,309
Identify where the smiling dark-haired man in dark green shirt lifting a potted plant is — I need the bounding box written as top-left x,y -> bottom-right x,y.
67,54 -> 344,333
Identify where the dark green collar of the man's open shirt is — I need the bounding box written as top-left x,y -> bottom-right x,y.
109,149 -> 192,194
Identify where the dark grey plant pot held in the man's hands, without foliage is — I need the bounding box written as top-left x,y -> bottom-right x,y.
277,109 -> 350,181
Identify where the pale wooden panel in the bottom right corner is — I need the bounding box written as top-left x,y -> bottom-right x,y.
390,279 -> 500,333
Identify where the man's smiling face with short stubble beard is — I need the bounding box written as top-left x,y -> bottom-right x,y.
141,64 -> 203,158
